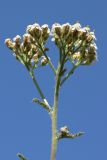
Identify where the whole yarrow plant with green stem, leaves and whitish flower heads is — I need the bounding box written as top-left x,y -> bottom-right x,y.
5,22 -> 97,160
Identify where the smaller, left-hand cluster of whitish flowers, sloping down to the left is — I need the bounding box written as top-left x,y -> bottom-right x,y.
5,23 -> 50,68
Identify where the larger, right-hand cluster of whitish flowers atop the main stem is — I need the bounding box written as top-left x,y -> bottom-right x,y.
52,23 -> 97,65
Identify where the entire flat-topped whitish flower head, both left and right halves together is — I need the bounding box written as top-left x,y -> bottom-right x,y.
5,23 -> 97,68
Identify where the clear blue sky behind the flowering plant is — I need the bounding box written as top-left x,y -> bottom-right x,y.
0,0 -> 107,160
